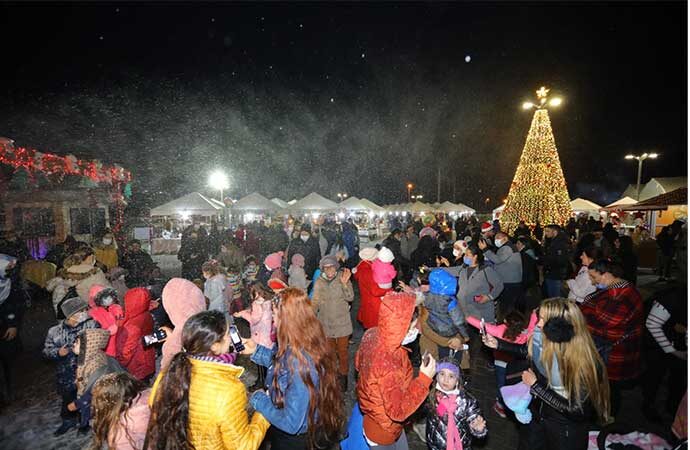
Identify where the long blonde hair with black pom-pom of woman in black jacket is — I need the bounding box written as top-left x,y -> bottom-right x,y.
527,298 -> 609,421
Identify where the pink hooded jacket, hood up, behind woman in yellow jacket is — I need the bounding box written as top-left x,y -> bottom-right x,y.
161,278 -> 206,370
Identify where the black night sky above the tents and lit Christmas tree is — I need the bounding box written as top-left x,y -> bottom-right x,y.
0,2 -> 688,210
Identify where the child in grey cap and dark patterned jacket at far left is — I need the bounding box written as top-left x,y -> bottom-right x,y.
43,297 -> 98,436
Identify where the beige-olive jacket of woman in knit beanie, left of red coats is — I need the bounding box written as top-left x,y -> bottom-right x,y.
312,271 -> 355,338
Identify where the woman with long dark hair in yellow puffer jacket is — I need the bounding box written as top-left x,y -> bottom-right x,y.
148,311 -> 269,450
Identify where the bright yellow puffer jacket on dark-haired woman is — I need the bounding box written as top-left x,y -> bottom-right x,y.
150,359 -> 270,450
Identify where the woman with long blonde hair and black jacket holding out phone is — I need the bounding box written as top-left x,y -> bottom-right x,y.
483,298 -> 609,450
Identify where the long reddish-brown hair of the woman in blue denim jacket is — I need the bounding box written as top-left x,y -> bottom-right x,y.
272,288 -> 344,448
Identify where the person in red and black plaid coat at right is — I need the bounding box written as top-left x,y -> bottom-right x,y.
580,259 -> 644,416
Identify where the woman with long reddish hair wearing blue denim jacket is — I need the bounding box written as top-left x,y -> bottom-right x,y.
247,288 -> 344,450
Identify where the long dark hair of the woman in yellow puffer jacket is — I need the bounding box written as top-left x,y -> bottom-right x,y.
148,311 -> 228,450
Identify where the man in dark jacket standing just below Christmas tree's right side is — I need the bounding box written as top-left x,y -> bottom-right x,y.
543,225 -> 570,298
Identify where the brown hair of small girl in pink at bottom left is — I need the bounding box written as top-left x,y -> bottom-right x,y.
91,372 -> 146,450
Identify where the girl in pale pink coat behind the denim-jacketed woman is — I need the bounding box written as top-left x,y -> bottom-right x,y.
233,284 -> 275,389
